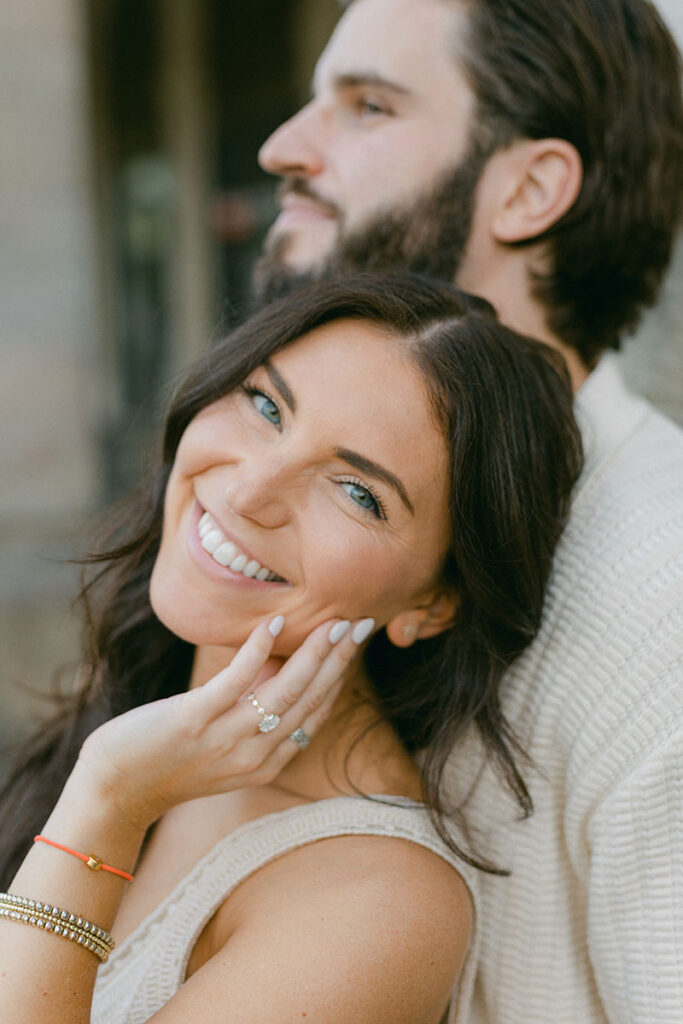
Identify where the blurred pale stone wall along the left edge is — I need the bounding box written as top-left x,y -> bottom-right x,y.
0,0 -> 98,761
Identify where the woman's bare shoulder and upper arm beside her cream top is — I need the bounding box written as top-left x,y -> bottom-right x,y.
190,834 -> 473,1024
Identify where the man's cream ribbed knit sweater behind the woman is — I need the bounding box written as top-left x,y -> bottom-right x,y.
451,356 -> 683,1024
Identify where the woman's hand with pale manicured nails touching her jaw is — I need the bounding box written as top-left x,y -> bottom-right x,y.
75,616 -> 374,828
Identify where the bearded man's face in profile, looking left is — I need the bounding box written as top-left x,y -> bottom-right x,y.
255,0 -> 487,301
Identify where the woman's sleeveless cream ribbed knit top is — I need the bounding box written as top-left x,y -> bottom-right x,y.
90,797 -> 478,1024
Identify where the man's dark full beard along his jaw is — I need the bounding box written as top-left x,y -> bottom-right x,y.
253,144 -> 490,305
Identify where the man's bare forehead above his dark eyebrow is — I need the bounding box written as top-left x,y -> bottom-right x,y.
313,0 -> 461,93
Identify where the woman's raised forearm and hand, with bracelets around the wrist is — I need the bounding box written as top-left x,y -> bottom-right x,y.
0,623 -> 357,1024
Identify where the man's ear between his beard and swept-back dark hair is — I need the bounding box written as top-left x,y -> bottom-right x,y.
490,138 -> 584,243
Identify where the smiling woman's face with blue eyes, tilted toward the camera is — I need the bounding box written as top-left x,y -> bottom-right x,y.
152,319 -> 456,654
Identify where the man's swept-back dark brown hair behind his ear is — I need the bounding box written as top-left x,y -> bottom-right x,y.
344,0 -> 683,367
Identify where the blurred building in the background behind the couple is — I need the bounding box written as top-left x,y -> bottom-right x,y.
0,0 -> 683,770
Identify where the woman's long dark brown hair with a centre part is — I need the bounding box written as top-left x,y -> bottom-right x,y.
0,274 -> 582,884
